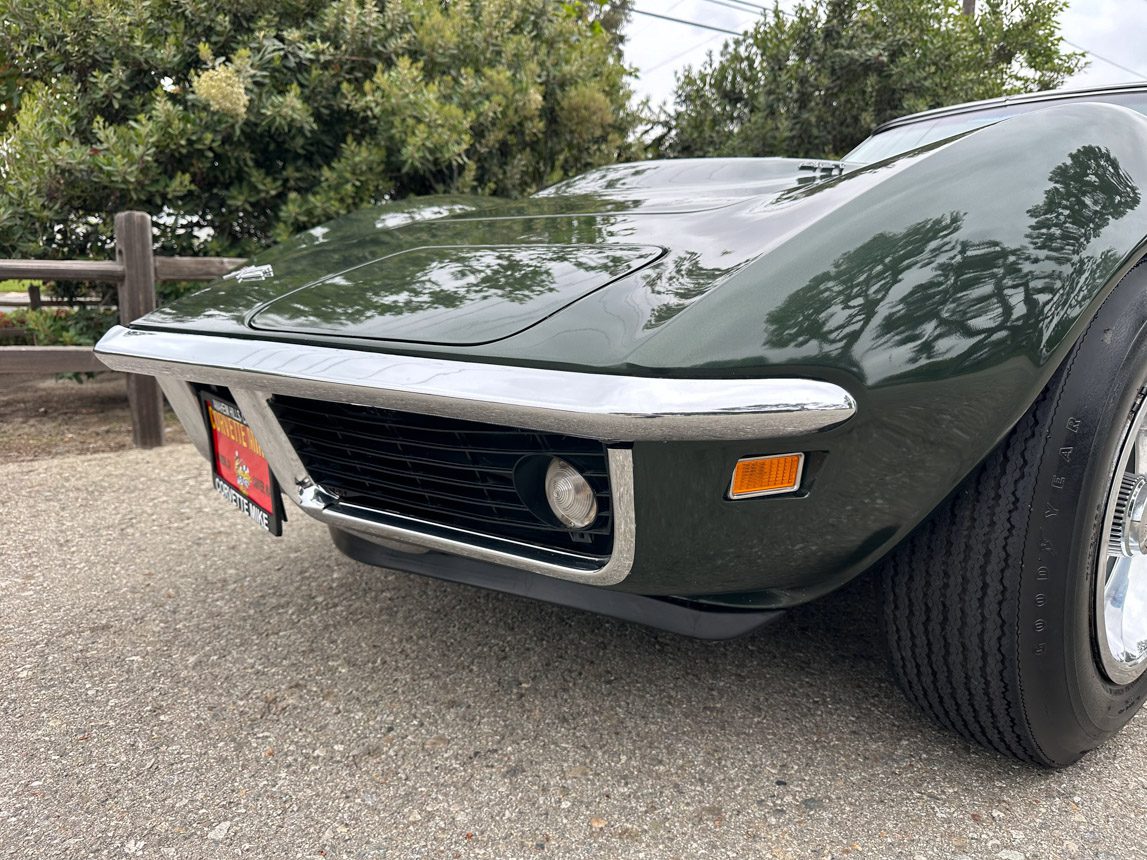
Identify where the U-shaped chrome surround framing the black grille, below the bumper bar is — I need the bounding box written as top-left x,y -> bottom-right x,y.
231,388 -> 637,585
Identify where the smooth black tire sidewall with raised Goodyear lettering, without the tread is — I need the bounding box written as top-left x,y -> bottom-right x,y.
1023,265 -> 1147,766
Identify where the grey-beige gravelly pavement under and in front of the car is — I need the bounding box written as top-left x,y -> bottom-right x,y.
0,445 -> 1147,860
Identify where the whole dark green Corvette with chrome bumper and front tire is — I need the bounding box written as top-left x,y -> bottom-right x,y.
96,86 -> 1147,766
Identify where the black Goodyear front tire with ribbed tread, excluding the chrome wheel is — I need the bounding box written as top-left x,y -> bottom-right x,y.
883,264 -> 1147,767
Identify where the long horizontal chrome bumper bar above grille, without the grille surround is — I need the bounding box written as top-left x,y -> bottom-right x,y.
95,326 -> 856,441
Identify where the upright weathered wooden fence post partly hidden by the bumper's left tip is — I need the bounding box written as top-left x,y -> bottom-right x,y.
116,212 -> 163,448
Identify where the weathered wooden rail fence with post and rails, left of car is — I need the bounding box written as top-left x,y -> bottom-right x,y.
0,212 -> 247,448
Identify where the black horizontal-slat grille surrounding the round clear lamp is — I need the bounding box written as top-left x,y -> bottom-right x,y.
271,396 -> 612,556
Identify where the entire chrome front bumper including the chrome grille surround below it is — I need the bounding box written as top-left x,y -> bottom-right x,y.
95,326 -> 856,585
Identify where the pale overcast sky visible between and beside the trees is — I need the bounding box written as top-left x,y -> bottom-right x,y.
625,0 -> 1147,104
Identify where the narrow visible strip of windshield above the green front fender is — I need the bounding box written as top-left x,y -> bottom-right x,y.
841,93 -> 1147,164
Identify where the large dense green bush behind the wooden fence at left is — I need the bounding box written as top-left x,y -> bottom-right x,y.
0,0 -> 633,257
